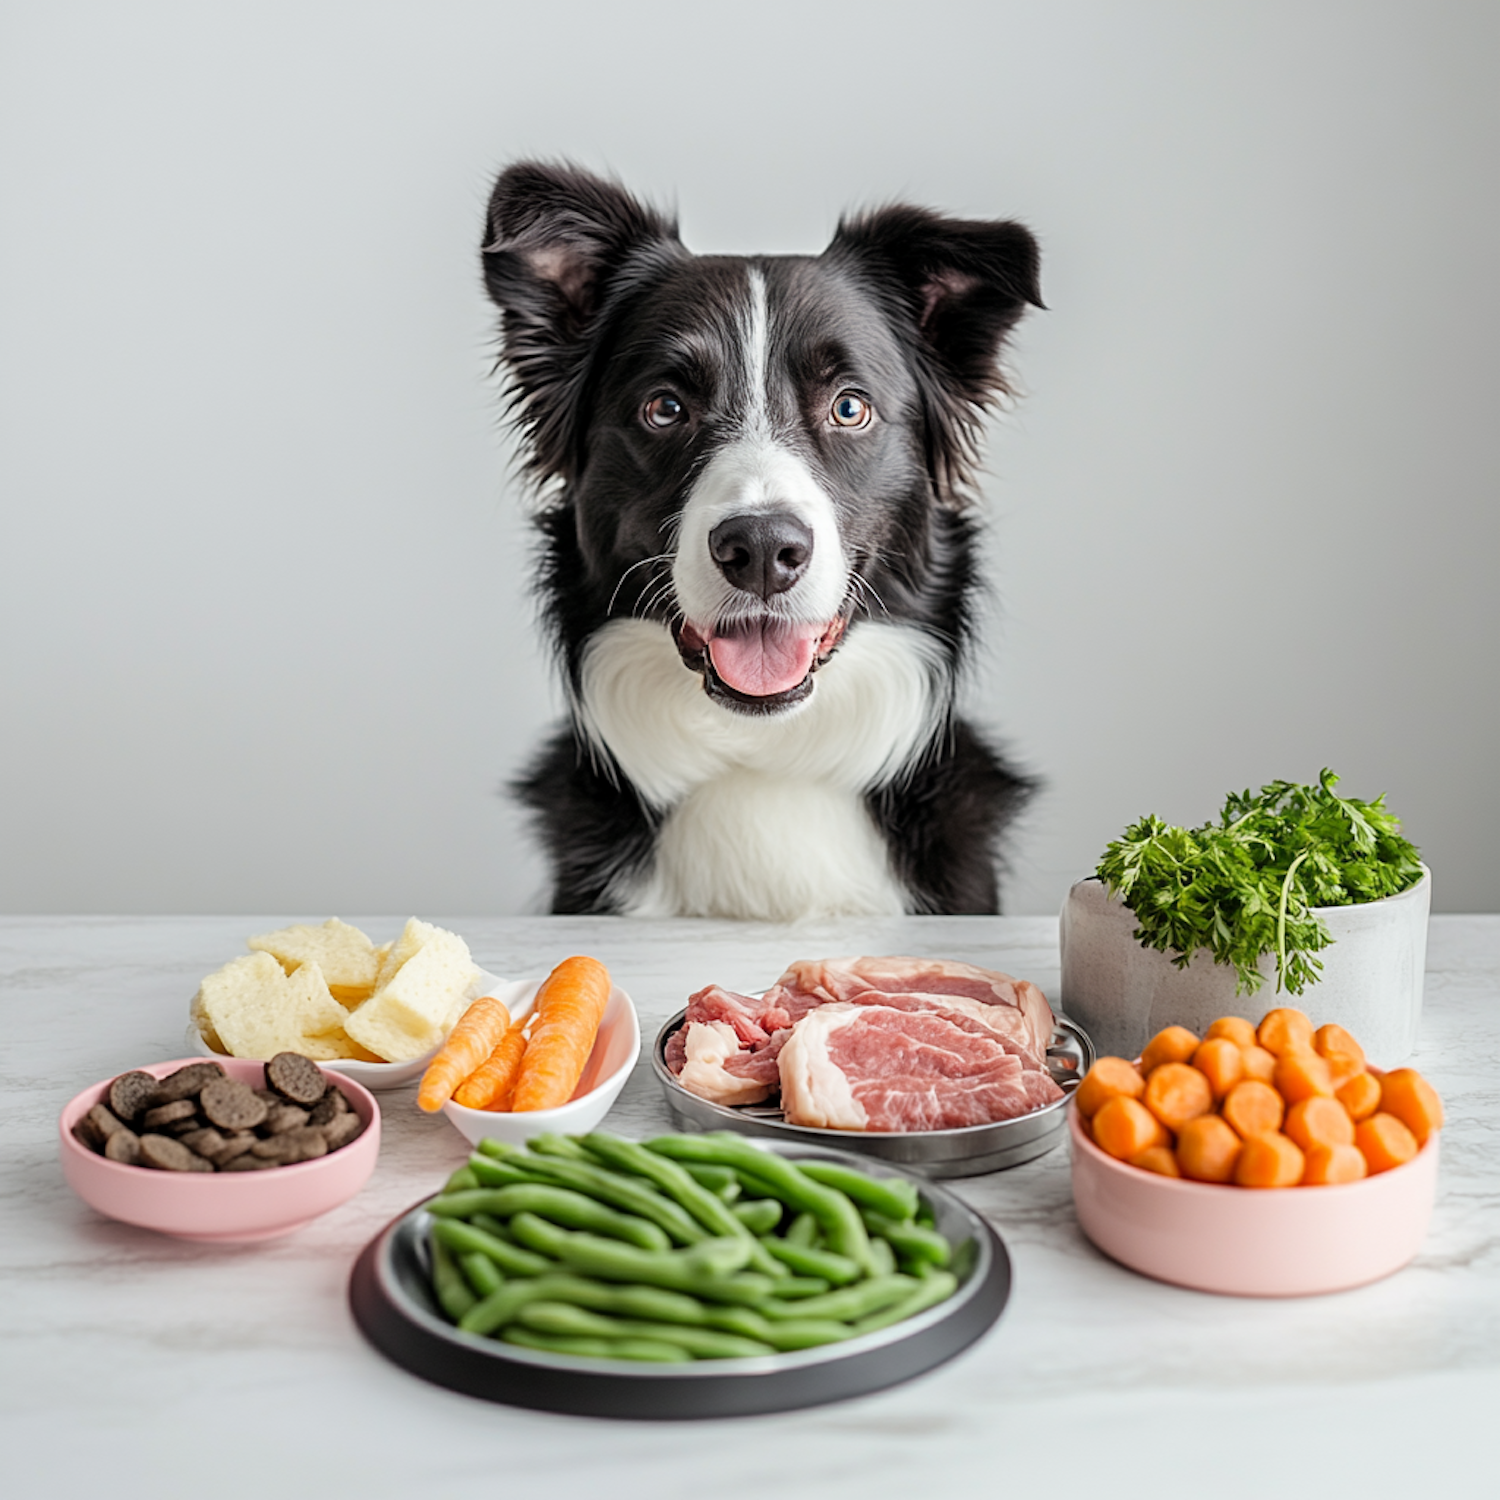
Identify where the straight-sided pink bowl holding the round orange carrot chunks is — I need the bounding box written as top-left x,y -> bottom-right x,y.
1068,1104 -> 1439,1298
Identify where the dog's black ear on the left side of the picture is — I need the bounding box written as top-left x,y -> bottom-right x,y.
480,162 -> 683,479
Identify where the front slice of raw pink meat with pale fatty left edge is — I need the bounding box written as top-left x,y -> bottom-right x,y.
780,1002 -> 1062,1131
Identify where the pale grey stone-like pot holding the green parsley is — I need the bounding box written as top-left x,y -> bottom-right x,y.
1061,866 -> 1433,1068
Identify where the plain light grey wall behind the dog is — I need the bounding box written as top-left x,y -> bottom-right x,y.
0,0 -> 1500,917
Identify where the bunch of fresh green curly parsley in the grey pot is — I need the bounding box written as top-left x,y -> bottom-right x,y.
1097,770 -> 1422,995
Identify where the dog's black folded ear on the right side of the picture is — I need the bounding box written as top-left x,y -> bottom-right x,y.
827,204 -> 1044,504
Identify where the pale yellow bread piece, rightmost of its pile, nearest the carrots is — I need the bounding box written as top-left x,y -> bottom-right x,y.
344,918 -> 479,1062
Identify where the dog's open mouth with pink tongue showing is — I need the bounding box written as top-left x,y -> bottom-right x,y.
672,615 -> 849,714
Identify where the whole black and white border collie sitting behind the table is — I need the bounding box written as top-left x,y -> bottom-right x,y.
483,162 -> 1041,921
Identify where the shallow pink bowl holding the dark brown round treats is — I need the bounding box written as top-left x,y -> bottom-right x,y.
57,1058 -> 380,1244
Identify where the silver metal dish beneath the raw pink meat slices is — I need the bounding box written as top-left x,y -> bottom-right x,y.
651,1010 -> 1095,1178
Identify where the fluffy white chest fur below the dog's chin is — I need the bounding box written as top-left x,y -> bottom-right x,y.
579,620 -> 947,921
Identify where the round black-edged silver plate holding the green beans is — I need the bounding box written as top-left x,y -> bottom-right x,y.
350,1142 -> 1011,1421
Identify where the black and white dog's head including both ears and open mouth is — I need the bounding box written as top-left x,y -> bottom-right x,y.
483,164 -> 1041,714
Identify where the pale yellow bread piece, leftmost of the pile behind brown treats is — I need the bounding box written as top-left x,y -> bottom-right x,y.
192,953 -> 350,1062
